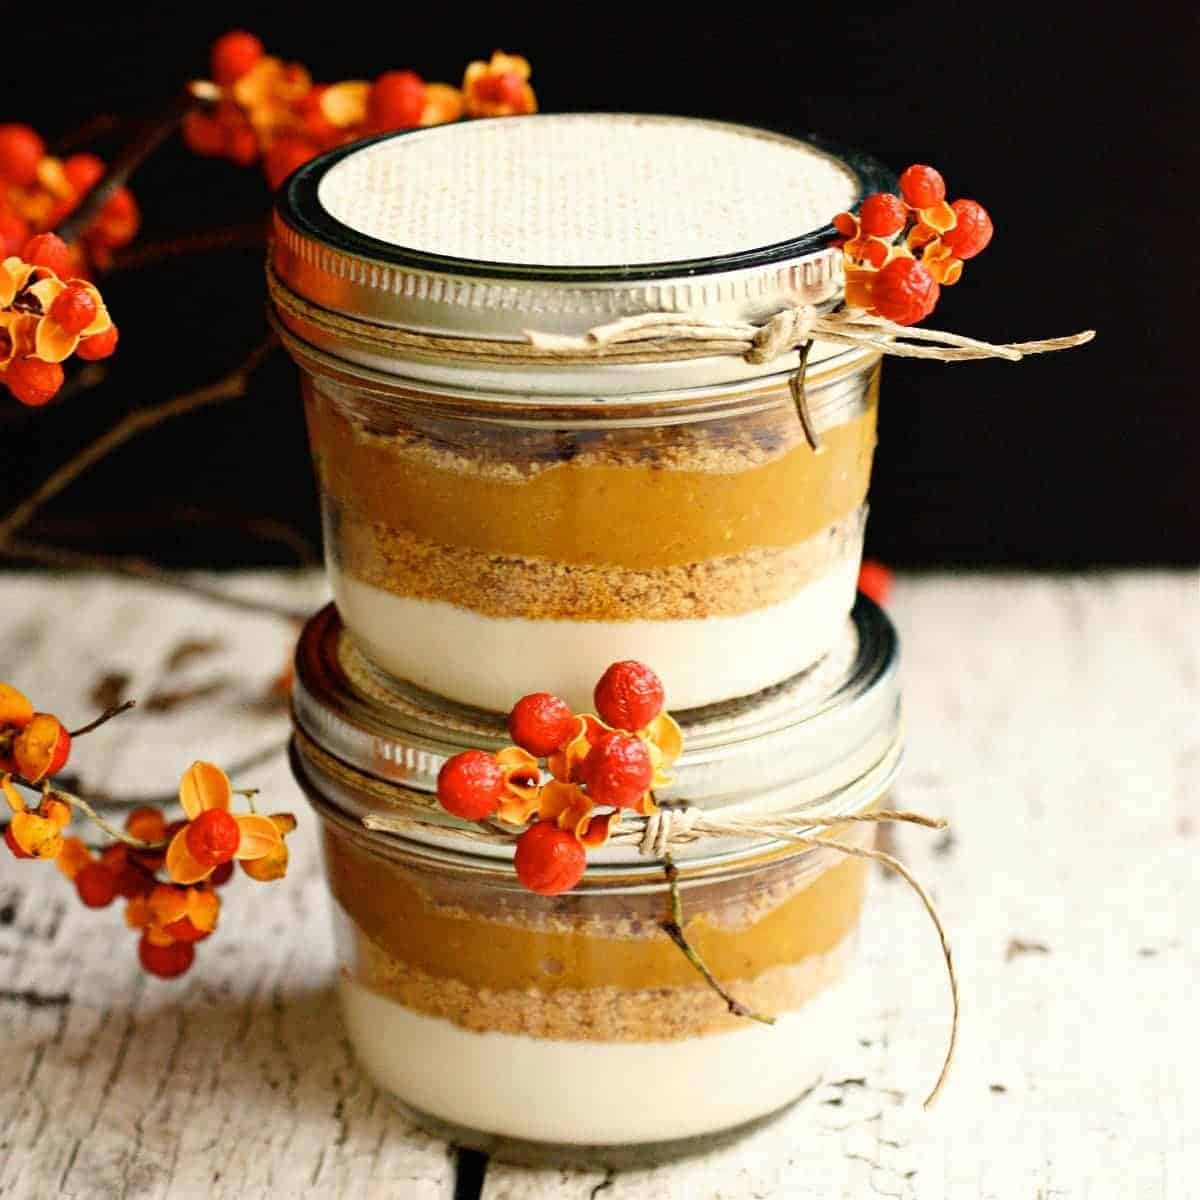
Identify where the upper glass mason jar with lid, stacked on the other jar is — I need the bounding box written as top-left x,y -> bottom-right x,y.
272,116 -> 878,710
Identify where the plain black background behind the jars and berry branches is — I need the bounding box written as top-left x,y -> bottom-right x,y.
0,2 -> 1200,565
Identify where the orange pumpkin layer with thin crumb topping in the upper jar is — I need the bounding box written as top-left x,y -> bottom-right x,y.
306,384 -> 875,571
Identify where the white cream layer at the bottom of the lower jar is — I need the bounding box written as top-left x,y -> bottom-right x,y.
340,976 -> 854,1145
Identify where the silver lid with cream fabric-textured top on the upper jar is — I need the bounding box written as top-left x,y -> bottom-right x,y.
271,113 -> 884,390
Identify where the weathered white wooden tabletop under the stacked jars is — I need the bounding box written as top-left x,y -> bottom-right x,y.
0,572 -> 1200,1200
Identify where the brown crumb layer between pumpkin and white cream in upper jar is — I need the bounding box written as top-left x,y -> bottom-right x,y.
326,508 -> 863,620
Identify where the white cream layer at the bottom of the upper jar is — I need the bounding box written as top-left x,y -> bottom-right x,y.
331,554 -> 858,712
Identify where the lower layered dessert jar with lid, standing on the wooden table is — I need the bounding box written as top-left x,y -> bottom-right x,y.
293,600 -> 900,1163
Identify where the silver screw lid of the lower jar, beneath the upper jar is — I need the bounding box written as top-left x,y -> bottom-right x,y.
293,596 -> 901,862
